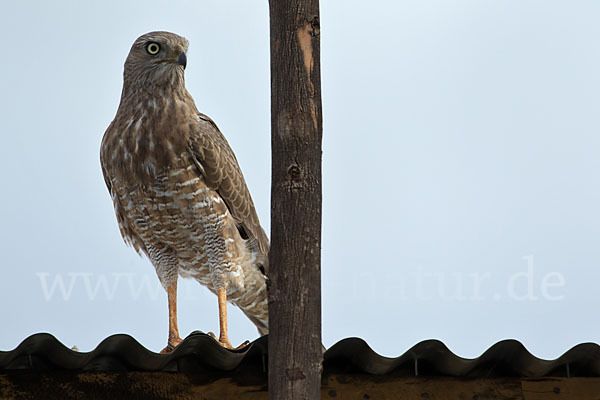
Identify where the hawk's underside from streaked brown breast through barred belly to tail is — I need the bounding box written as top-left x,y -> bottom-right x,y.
101,94 -> 268,334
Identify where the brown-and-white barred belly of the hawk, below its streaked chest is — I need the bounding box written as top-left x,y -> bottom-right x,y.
113,154 -> 256,294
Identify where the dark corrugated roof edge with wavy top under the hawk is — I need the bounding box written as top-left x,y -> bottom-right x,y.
0,332 -> 600,380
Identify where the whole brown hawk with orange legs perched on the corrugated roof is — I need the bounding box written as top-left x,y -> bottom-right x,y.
100,32 -> 269,352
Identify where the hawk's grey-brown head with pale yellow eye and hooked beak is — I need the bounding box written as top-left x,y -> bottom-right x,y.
123,32 -> 189,86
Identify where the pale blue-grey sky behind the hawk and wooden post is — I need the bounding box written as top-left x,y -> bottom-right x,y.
0,0 -> 600,358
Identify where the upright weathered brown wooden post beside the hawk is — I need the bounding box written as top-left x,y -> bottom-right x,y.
269,0 -> 323,400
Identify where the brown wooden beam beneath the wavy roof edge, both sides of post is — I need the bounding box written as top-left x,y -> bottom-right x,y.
0,371 -> 600,400
